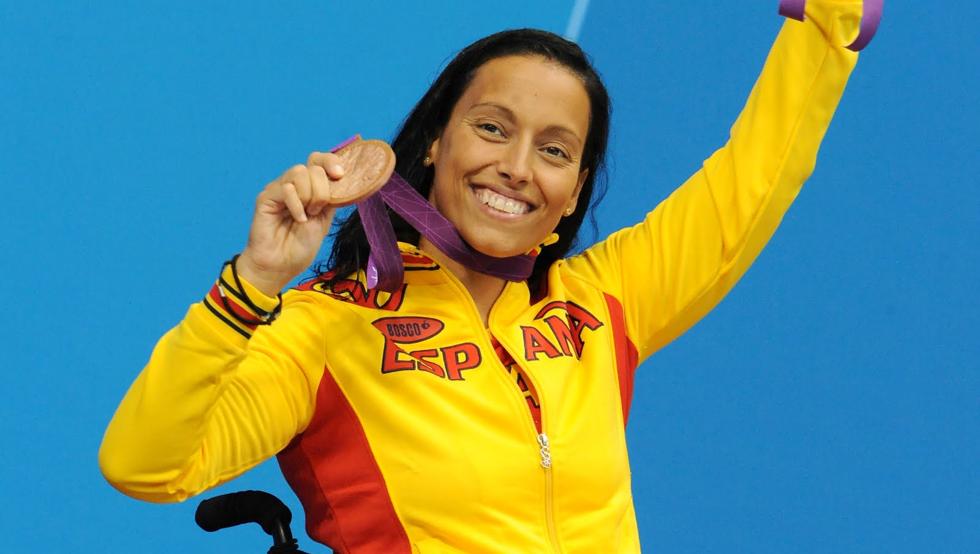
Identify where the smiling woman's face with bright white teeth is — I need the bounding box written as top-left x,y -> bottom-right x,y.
429,56 -> 590,257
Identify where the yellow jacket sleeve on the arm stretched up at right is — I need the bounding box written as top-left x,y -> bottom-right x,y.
565,0 -> 862,360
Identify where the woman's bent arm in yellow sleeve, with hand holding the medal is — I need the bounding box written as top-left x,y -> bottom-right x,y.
99,153 -> 356,502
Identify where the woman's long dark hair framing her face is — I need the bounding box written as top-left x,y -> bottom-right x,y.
315,29 -> 611,291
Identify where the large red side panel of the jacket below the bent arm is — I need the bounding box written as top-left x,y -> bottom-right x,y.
279,364 -> 412,554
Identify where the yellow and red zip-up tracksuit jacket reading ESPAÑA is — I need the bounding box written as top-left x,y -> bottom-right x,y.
100,0 -> 861,553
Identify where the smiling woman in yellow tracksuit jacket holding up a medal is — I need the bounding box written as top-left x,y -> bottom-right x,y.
100,0 -> 861,553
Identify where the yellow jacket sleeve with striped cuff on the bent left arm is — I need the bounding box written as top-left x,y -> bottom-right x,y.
99,267 -> 325,502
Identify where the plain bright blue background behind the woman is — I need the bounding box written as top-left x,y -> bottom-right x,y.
0,0 -> 980,553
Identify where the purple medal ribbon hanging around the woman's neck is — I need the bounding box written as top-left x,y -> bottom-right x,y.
331,136 -> 535,292
